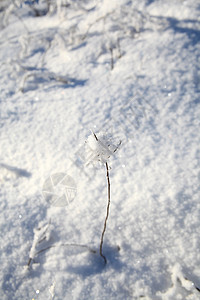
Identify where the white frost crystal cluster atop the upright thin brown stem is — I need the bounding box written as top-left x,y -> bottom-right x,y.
85,132 -> 121,166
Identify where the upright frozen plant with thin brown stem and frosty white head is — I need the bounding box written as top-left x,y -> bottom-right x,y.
86,132 -> 121,264
